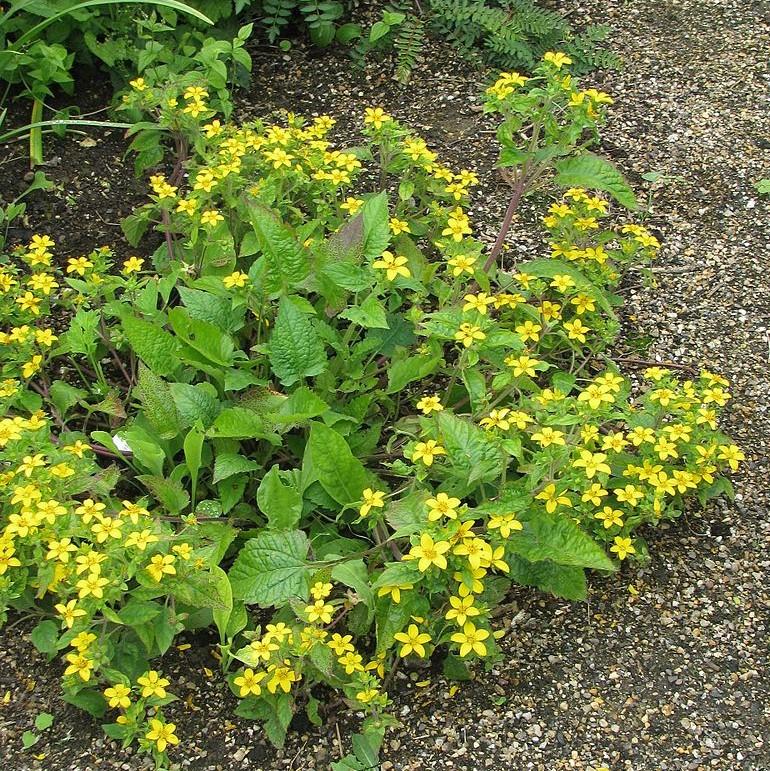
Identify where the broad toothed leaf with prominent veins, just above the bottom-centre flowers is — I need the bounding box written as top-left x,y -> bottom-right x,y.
230,530 -> 312,608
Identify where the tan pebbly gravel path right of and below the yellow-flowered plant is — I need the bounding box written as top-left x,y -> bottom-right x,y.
0,0 -> 770,771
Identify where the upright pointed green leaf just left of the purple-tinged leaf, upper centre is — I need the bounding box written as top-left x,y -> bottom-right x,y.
248,204 -> 310,295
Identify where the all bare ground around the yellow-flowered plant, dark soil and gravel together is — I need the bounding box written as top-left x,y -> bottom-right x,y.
0,0 -> 770,771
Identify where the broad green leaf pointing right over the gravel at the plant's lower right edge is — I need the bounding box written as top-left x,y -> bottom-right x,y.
508,512 -> 617,571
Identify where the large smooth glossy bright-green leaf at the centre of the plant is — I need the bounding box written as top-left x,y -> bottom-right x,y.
305,423 -> 370,506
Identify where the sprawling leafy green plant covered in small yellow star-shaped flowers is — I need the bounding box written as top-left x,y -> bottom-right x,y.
0,54 -> 742,768
